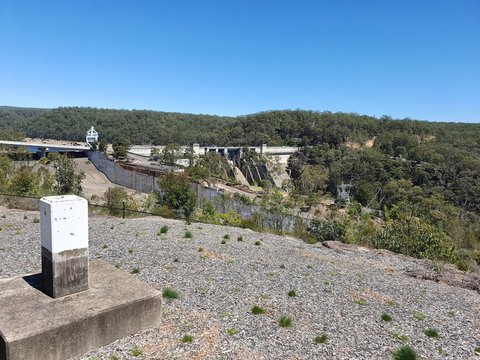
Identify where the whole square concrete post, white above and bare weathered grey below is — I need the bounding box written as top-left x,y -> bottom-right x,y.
40,195 -> 88,298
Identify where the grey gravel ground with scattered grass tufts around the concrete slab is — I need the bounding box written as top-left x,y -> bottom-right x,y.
0,208 -> 480,360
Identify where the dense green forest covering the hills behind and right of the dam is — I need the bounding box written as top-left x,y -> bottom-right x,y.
0,107 -> 480,266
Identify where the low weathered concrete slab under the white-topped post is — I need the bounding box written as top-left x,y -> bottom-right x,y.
0,260 -> 162,360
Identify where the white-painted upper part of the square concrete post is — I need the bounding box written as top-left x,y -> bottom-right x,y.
40,195 -> 88,254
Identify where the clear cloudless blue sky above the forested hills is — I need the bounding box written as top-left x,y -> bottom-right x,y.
0,0 -> 480,122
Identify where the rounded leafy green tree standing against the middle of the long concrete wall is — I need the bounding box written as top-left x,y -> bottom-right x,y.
159,172 -> 197,220
